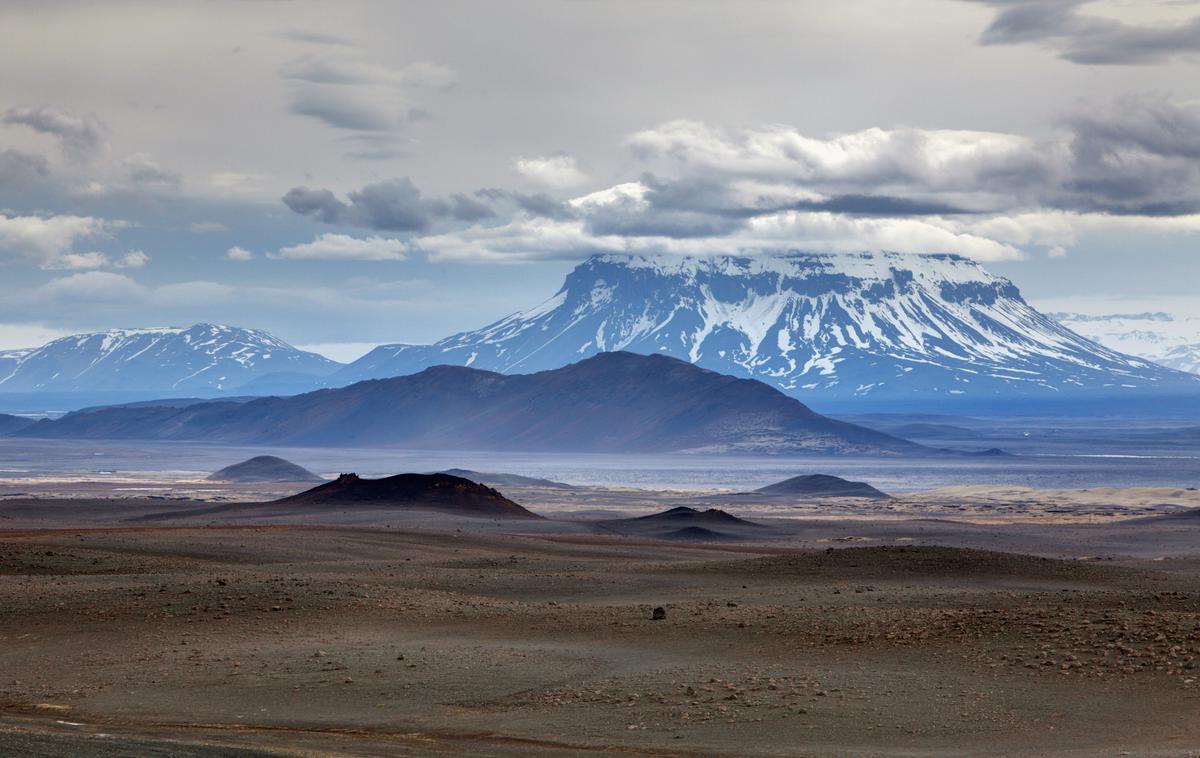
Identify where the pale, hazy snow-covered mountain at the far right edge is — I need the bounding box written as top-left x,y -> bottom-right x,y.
1050,312 -> 1200,374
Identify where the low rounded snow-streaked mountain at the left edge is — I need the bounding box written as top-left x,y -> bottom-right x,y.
0,324 -> 341,395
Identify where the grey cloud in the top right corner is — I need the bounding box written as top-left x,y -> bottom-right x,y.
972,0 -> 1200,65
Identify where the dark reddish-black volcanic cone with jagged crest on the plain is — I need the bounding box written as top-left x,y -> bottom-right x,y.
275,474 -> 541,518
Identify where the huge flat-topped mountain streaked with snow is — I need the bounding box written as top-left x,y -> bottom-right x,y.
331,253 -> 1200,407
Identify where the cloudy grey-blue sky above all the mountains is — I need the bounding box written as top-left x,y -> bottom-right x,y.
0,0 -> 1200,360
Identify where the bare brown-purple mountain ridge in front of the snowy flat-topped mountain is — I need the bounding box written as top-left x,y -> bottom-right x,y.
19,353 -> 916,455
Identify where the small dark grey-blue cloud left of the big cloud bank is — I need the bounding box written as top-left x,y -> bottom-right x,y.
282,176 -> 496,231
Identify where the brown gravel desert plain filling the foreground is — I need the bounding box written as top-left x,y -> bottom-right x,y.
0,446 -> 1200,756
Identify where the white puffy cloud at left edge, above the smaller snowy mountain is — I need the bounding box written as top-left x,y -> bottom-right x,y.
0,215 -> 120,269
